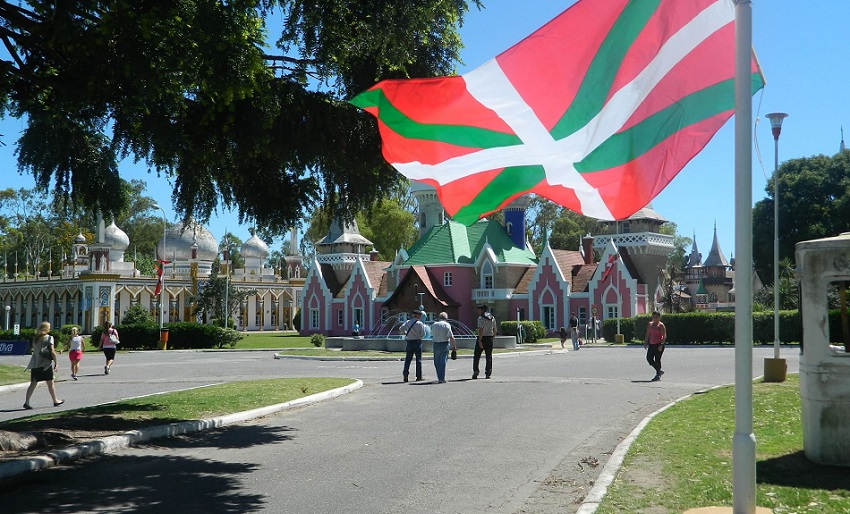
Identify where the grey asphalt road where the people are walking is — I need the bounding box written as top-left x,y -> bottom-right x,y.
0,347 -> 798,514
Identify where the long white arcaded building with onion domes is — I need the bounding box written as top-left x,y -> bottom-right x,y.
0,215 -> 304,333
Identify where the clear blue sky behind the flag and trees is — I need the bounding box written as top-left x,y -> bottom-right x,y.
0,0 -> 850,259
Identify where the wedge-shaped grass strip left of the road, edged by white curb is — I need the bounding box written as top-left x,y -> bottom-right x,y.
0,378 -> 355,431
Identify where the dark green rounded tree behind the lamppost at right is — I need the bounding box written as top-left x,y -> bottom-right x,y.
753,150 -> 850,282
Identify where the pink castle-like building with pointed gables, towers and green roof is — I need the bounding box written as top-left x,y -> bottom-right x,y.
300,182 -> 734,336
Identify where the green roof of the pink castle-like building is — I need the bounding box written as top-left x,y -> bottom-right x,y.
404,220 -> 537,266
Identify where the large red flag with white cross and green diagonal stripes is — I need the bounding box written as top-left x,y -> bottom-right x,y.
351,0 -> 764,224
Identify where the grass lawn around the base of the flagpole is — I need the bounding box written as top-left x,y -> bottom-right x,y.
597,374 -> 850,514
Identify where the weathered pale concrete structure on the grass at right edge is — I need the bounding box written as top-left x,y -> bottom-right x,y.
797,232 -> 850,466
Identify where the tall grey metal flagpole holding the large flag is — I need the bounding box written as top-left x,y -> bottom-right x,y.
732,0 -> 756,514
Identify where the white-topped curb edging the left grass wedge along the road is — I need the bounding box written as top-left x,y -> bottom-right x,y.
0,380 -> 363,483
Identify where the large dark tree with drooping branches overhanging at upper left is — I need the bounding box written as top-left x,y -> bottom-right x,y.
0,0 -> 481,231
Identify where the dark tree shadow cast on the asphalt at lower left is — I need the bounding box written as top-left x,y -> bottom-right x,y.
0,425 -> 293,514
